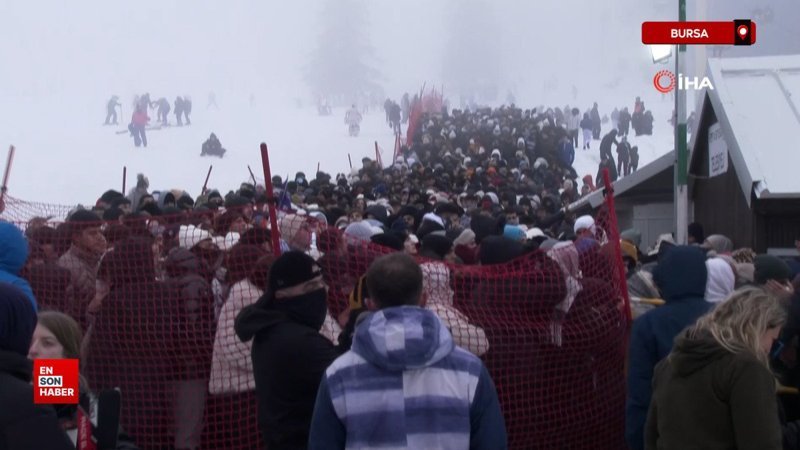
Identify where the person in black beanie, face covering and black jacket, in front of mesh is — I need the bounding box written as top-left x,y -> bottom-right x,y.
234,251 -> 338,450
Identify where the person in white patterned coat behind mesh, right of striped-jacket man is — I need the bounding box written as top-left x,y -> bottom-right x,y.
420,262 -> 489,356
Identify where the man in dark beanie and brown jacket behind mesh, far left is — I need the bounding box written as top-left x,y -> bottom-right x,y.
58,210 -> 107,327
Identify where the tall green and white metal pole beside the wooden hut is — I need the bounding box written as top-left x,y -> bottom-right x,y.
675,0 -> 689,245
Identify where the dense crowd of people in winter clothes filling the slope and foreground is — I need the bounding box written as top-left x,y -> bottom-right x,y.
0,101 -> 800,449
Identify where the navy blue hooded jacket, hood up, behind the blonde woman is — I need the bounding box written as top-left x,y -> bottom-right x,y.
625,246 -> 710,450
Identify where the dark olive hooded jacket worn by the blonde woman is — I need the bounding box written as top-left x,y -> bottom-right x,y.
645,335 -> 783,450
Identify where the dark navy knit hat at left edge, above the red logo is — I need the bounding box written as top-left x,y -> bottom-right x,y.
0,283 -> 36,356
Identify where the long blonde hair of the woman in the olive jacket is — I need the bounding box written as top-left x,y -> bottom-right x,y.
685,287 -> 787,367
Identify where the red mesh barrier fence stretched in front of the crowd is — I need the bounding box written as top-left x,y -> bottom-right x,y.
3,195 -> 627,449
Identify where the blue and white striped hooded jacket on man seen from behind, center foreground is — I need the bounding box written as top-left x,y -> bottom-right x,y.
309,306 -> 507,449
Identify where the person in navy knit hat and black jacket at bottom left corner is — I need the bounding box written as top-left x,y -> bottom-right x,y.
0,283 -> 75,450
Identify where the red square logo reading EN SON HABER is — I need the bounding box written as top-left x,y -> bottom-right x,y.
33,359 -> 79,404
